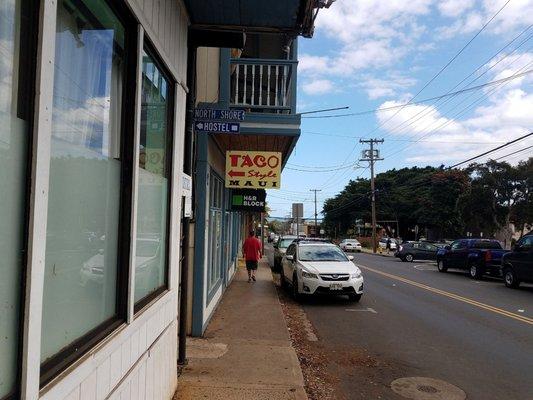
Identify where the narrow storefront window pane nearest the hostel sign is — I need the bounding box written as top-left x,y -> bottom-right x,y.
135,51 -> 172,306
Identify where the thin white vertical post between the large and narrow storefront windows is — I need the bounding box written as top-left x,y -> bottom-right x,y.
126,24 -> 144,324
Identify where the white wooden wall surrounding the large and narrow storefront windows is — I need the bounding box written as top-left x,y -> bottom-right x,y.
21,0 -> 189,400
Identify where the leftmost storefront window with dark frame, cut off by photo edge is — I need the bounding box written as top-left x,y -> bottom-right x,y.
0,0 -> 31,399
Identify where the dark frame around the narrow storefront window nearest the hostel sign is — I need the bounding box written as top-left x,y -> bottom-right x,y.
131,33 -> 176,317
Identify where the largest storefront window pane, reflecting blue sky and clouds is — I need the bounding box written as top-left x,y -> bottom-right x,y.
41,0 -> 126,371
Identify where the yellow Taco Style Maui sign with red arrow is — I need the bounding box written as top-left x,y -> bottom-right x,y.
226,151 -> 281,189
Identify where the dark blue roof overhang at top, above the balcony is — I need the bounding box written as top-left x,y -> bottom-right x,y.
184,0 -> 315,36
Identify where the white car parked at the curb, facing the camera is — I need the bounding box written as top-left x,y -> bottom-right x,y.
281,240 -> 363,301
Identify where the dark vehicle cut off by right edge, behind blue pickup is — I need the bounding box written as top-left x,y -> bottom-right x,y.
502,234 -> 533,288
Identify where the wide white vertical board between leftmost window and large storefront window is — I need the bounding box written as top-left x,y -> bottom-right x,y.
21,0 -> 57,400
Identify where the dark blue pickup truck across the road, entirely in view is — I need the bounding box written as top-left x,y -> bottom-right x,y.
437,239 -> 508,279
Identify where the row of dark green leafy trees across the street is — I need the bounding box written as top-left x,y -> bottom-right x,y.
323,158 -> 533,238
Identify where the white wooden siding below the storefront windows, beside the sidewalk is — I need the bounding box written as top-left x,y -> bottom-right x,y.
40,292 -> 178,400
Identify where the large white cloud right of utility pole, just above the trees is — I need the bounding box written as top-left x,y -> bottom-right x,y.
377,68 -> 533,164
